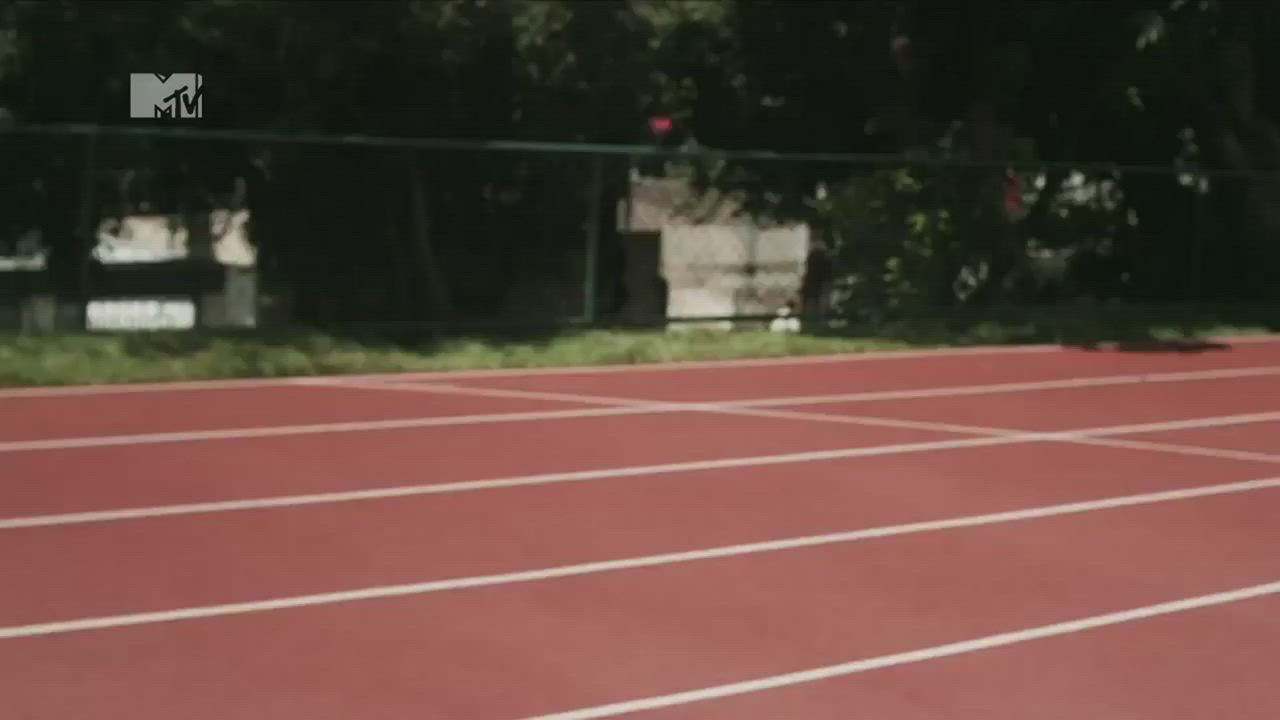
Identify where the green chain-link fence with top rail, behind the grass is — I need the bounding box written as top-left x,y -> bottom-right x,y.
0,127 -> 1280,329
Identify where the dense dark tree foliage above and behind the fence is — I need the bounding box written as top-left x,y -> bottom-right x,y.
0,0 -> 1280,320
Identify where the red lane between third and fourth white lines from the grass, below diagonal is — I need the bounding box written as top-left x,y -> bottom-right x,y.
0,443 -> 1277,625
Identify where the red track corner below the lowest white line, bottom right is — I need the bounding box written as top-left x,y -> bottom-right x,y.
627,596 -> 1280,720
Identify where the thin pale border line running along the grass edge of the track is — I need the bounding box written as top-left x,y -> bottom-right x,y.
0,334 -> 1280,400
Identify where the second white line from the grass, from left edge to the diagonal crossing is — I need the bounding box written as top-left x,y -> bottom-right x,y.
0,404 -> 684,452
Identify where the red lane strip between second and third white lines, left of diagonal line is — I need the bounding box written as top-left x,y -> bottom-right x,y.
0,407 -> 964,518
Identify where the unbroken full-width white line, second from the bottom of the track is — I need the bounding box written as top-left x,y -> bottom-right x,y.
0,478 -> 1280,639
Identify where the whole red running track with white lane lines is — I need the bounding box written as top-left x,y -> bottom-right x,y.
0,338 -> 1280,720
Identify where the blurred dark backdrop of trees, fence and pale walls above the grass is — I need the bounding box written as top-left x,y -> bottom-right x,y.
0,0 -> 1280,337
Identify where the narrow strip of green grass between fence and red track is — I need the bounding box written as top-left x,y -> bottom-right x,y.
0,309 -> 1280,386
